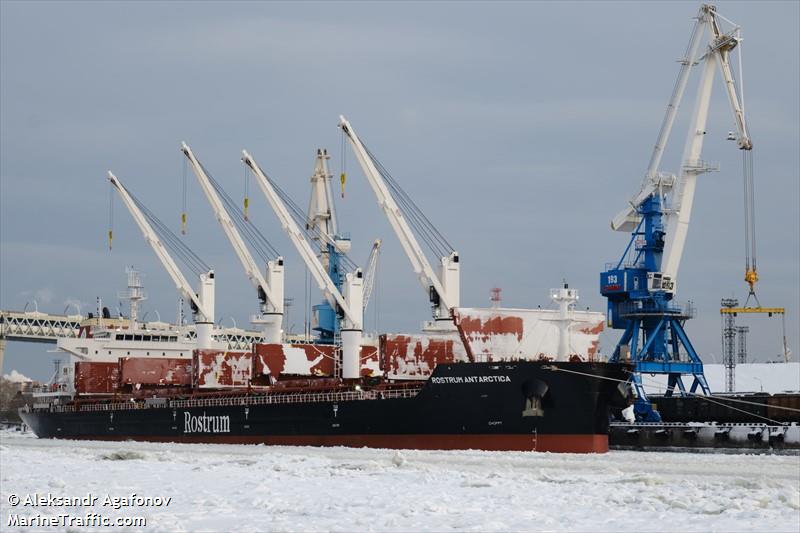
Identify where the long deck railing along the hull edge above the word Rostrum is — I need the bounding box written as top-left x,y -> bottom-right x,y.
42,386 -> 422,413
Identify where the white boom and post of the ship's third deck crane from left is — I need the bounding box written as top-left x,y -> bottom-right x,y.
242,150 -> 364,379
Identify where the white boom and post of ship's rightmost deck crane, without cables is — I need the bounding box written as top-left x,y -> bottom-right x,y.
339,116 -> 460,321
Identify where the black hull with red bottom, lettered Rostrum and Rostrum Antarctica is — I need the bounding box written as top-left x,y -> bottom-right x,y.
20,362 -> 627,452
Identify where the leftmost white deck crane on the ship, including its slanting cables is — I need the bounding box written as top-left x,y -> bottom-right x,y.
108,170 -> 219,350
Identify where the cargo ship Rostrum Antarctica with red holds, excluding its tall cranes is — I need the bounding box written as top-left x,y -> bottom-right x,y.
20,289 -> 631,453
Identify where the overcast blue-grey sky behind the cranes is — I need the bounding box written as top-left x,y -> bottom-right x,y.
0,1 -> 800,378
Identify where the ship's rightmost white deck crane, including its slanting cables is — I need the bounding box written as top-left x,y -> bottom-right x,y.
339,116 -> 461,332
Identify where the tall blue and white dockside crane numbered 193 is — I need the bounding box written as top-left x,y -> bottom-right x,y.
600,4 -> 758,420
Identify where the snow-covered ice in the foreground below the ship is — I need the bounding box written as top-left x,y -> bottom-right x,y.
0,431 -> 800,532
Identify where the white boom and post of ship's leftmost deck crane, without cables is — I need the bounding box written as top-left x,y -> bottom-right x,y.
108,170 -> 214,349
